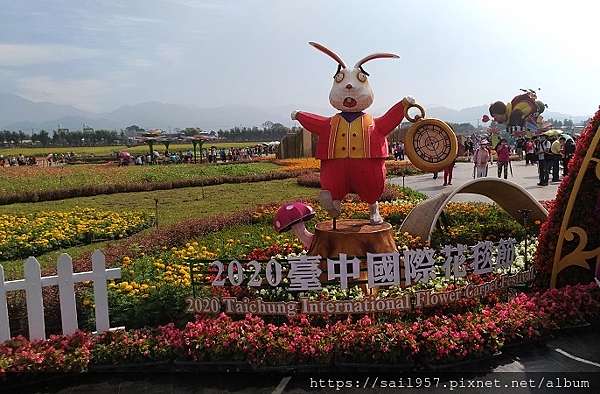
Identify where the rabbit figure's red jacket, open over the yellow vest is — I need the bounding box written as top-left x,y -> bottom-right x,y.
296,101 -> 404,160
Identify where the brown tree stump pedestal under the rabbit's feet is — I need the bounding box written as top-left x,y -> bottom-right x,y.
308,219 -> 398,290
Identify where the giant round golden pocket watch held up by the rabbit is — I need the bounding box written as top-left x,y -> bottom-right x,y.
404,104 -> 458,172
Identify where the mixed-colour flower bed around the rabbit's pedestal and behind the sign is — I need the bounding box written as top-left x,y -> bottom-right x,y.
1,187 -> 535,333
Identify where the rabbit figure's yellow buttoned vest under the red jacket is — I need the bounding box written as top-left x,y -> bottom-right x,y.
329,114 -> 373,159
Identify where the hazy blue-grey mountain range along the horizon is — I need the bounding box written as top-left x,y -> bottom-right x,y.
0,93 -> 588,133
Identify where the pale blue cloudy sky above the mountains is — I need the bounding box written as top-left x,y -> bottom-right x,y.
0,0 -> 600,115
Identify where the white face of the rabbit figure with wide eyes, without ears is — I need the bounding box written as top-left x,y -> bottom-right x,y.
329,68 -> 373,112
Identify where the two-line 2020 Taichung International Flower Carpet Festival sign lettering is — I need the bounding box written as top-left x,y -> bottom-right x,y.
186,238 -> 535,316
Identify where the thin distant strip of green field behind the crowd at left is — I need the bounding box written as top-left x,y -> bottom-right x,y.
0,142 -> 270,157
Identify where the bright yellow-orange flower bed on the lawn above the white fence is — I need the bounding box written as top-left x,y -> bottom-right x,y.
0,208 -> 154,260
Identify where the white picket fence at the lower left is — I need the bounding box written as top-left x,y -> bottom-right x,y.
0,250 -> 121,341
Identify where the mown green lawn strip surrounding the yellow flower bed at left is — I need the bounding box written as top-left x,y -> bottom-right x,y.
0,179 -> 317,279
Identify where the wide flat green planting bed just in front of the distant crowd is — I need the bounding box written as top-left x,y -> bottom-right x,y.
0,162 -> 281,193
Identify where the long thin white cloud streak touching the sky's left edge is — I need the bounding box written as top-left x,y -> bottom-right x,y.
0,44 -> 101,67
